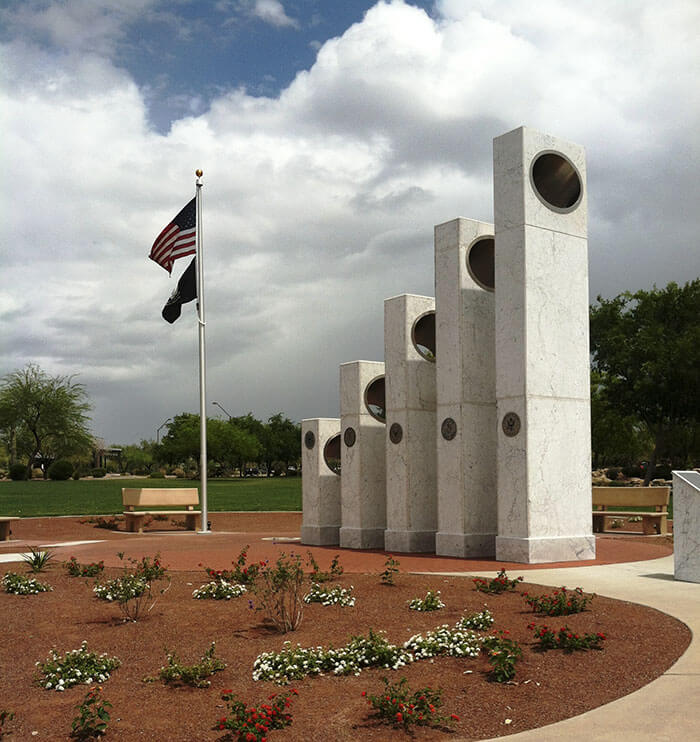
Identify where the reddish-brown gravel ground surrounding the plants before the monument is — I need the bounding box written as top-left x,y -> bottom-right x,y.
0,513 -> 690,742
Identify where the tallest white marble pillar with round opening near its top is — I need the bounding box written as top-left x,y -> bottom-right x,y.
493,127 -> 595,563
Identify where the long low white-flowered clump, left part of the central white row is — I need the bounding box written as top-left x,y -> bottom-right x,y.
253,629 -> 413,684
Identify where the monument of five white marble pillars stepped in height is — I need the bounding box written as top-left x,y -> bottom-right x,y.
301,127 -> 595,563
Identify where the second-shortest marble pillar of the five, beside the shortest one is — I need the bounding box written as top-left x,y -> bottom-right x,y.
340,361 -> 386,549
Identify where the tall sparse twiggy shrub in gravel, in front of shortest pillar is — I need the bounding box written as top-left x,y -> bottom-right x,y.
251,552 -> 304,634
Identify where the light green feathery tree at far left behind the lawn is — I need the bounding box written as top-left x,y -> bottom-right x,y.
0,363 -> 92,476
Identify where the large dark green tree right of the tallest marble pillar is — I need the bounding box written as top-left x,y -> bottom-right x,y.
591,279 -> 700,484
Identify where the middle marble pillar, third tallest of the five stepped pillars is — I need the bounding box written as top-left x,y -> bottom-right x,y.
384,294 -> 437,552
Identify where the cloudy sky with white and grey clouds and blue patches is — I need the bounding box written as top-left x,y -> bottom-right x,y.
0,0 -> 700,443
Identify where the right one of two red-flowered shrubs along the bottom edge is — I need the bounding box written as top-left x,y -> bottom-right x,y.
362,678 -> 459,732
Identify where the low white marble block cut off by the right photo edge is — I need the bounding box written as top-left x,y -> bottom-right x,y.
673,471 -> 700,582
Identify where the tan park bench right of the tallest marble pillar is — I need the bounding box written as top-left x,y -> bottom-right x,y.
593,487 -> 671,536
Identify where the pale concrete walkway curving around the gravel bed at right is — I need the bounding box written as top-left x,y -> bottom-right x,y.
434,556 -> 700,742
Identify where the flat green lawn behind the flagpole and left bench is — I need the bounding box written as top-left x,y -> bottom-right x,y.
0,477 -> 301,517
